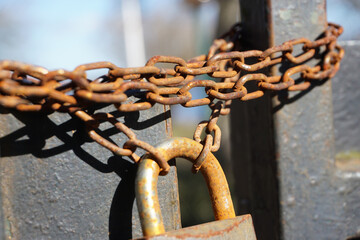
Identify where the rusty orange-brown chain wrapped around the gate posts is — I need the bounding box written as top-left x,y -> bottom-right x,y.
0,23 -> 344,174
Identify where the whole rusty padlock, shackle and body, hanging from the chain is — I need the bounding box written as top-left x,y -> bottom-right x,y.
135,138 -> 256,240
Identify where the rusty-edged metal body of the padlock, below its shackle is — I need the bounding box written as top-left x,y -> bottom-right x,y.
136,215 -> 256,240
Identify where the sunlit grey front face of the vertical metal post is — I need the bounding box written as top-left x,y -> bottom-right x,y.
271,0 -> 346,239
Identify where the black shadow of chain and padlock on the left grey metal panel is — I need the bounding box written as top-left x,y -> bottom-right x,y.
0,106 -> 174,239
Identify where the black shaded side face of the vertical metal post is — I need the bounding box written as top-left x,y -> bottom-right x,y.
230,0 -> 280,239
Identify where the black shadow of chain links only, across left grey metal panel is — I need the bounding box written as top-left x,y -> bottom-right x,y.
0,109 -> 170,159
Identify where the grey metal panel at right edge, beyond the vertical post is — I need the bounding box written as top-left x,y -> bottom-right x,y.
328,41 -> 360,238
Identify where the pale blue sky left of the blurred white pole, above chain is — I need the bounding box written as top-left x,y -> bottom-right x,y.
1,0 -> 122,69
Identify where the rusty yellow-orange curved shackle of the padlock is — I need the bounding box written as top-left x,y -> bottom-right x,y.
135,137 -> 235,237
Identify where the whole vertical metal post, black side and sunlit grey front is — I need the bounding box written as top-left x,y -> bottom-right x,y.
231,0 -> 358,239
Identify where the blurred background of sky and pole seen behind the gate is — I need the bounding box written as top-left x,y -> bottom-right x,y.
0,0 -> 360,229
